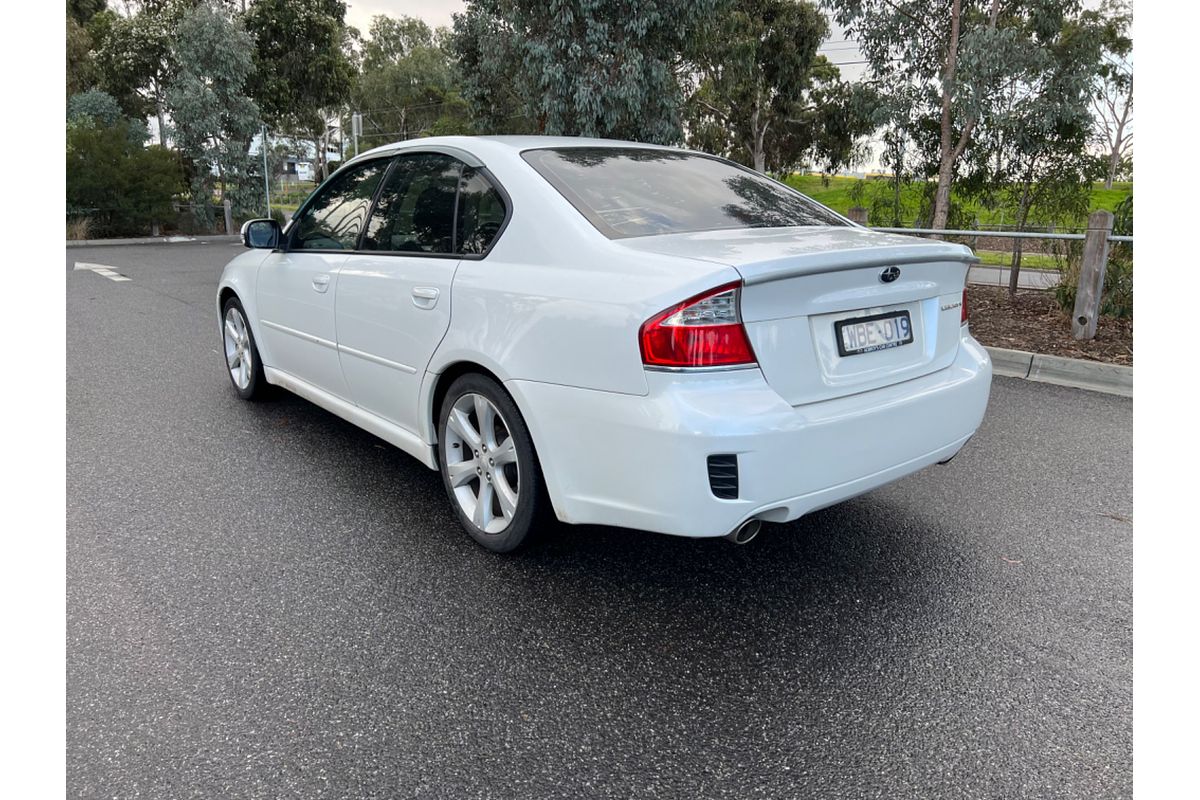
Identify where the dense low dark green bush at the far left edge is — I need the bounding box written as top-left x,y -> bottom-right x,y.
66,118 -> 184,235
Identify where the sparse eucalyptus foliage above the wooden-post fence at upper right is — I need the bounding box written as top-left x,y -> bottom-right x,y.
828,0 -> 1099,227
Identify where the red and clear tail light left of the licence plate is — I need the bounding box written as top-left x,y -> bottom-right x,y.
638,282 -> 755,367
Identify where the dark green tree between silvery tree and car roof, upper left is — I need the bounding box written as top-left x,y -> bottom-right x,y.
242,0 -> 354,178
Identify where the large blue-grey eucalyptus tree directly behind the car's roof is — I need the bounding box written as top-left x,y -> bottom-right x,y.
451,0 -> 715,143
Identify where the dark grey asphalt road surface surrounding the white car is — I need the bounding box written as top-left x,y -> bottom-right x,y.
66,242 -> 1132,799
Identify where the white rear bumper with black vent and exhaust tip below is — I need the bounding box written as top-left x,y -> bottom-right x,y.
506,333 -> 991,536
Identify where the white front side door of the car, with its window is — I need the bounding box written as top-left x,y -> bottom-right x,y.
256,158 -> 390,398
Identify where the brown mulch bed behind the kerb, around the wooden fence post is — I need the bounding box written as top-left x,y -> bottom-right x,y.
967,284 -> 1133,366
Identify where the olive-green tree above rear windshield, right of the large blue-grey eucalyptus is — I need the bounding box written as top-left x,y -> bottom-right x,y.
688,0 -> 874,172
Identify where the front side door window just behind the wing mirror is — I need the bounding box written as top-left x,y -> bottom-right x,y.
290,158 -> 389,249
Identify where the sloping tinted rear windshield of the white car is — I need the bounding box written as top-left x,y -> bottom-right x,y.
521,148 -> 846,239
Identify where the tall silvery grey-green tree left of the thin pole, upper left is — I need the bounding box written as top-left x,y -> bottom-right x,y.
166,5 -> 262,224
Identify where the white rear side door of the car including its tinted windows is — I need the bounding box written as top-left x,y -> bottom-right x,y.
336,154 -> 504,433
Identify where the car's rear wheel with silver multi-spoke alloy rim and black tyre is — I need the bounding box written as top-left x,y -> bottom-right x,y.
438,373 -> 553,553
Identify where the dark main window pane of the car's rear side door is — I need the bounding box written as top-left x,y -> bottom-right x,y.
362,154 -> 462,253
